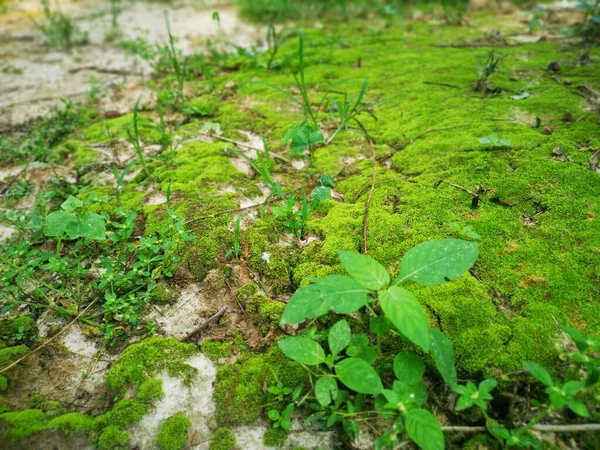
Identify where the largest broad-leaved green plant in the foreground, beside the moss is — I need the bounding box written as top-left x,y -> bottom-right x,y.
278,239 -> 478,450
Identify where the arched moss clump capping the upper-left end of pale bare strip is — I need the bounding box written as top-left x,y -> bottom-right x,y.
105,337 -> 196,390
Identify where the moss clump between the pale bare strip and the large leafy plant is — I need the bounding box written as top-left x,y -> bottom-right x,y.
214,346 -> 306,425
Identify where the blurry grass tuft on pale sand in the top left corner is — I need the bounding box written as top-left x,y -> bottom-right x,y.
32,0 -> 88,50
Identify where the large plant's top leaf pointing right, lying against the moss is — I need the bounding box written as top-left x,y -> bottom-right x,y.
394,239 -> 478,285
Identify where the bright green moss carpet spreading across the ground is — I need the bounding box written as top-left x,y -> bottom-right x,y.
0,2 -> 600,449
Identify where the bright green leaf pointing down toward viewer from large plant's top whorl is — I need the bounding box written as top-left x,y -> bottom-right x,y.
379,286 -> 429,352
